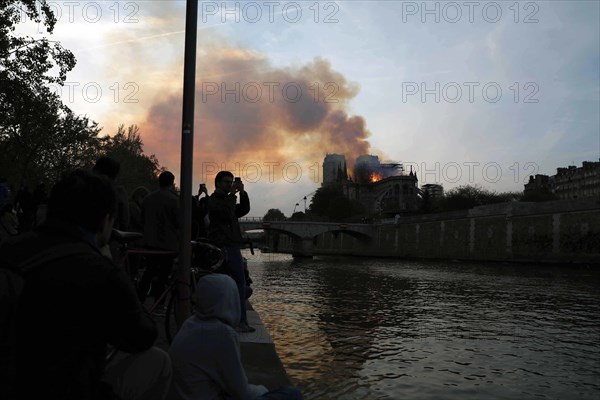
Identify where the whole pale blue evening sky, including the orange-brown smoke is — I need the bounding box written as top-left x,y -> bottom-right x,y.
16,0 -> 600,216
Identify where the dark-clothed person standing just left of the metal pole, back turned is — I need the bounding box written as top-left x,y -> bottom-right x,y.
138,171 -> 180,302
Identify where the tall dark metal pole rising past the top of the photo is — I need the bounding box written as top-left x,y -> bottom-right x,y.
175,0 -> 198,327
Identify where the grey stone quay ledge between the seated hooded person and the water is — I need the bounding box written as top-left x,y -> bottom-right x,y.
154,303 -> 290,390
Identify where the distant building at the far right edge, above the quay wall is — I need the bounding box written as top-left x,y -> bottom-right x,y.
554,161 -> 600,199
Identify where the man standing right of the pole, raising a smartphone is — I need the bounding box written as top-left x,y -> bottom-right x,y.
208,171 -> 255,332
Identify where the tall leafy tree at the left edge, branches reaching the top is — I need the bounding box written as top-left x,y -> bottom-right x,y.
0,0 -> 88,188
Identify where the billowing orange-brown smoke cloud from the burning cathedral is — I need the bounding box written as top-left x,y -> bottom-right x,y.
141,42 -> 370,181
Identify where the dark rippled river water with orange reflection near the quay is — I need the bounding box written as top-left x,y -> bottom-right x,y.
245,252 -> 600,400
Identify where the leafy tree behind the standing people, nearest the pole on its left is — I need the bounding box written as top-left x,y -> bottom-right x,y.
100,125 -> 165,193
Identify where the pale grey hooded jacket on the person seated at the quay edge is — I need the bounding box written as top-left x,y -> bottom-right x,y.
169,274 -> 267,400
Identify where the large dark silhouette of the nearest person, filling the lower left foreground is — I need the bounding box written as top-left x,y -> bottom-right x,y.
0,170 -> 171,400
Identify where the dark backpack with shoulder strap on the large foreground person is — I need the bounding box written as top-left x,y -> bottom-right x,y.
0,243 -> 90,399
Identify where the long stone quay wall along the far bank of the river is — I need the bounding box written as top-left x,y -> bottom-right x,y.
275,198 -> 600,265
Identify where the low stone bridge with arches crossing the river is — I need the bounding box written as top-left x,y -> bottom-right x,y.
240,218 -> 377,257
